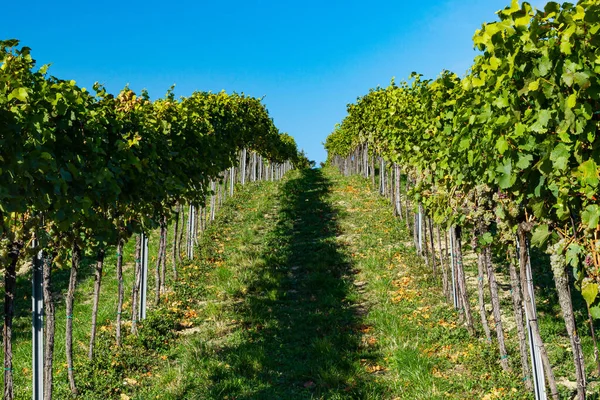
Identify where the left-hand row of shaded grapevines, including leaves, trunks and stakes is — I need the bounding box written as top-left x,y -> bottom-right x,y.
0,40 -> 308,399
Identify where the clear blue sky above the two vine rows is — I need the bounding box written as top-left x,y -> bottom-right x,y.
0,0 -> 544,162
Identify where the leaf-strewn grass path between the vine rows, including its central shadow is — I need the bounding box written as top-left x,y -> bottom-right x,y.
135,169 -> 529,399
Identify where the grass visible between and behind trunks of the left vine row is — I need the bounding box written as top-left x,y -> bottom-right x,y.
0,188 -> 219,399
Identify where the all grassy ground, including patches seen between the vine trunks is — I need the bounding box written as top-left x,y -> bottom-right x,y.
0,168 -> 600,400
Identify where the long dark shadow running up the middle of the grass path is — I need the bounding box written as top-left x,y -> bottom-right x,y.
203,170 -> 380,399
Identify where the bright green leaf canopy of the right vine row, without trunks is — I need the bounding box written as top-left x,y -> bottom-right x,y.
325,0 -> 600,312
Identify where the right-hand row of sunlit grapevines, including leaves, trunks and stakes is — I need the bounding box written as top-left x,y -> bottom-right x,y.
325,0 -> 600,399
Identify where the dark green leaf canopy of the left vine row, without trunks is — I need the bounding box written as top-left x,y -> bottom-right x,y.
0,40 -> 301,263
